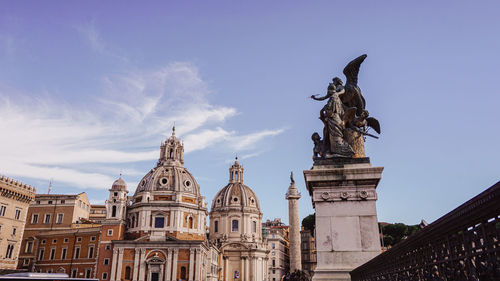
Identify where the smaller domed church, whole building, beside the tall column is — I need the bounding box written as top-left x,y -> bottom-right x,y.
210,159 -> 269,281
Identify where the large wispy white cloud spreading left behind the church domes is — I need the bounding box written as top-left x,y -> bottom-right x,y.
0,63 -> 283,190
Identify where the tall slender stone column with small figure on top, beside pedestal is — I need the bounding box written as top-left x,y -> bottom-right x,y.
285,173 -> 302,272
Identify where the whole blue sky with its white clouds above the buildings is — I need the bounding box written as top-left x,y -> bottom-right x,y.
0,1 -> 500,224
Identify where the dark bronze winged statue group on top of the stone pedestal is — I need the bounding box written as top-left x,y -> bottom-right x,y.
311,55 -> 380,159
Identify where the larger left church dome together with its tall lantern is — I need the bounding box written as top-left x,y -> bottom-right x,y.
134,127 -> 200,196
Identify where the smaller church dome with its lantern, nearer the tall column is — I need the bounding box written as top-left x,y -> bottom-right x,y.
210,158 -> 260,213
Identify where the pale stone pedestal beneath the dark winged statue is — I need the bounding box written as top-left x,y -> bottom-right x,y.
304,158 -> 384,281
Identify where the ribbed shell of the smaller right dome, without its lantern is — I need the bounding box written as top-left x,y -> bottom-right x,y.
210,182 -> 260,212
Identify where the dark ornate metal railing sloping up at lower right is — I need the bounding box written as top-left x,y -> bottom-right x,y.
351,182 -> 500,281
